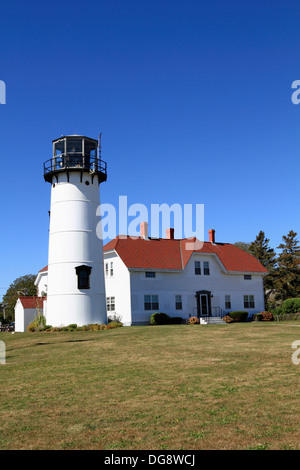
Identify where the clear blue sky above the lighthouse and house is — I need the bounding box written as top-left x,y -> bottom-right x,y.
0,0 -> 300,298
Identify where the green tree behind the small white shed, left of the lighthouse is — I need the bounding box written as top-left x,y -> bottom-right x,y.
2,274 -> 36,322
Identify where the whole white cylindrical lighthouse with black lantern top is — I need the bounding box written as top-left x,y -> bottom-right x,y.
44,135 -> 107,326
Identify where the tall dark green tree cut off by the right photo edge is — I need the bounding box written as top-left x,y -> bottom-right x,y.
276,230 -> 300,300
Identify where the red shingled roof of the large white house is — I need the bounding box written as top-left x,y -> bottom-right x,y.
103,236 -> 268,273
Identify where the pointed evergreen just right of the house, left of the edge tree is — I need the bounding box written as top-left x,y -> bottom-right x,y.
249,230 -> 277,305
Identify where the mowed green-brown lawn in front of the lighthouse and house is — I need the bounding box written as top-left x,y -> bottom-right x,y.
0,322 -> 300,450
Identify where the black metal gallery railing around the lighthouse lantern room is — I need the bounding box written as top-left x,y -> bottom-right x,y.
44,154 -> 107,181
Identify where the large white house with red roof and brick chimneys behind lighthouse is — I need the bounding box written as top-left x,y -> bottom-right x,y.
32,223 -> 267,326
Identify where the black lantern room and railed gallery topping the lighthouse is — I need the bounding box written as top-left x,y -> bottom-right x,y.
44,134 -> 107,183
